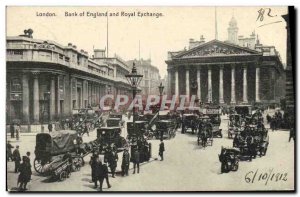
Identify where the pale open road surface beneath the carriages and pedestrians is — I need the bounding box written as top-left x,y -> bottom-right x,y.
7,114 -> 294,191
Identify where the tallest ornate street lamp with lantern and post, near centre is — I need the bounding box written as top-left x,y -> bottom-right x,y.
125,62 -> 143,139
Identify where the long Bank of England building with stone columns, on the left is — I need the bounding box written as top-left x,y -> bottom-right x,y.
6,32 -> 131,124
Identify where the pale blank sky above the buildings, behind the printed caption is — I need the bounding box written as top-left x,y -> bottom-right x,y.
6,6 -> 287,77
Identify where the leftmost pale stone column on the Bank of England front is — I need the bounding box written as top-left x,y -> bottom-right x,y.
22,73 -> 30,124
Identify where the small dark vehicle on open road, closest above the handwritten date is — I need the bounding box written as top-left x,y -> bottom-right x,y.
219,147 -> 240,173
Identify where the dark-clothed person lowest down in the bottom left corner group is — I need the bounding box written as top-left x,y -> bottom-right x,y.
18,156 -> 32,191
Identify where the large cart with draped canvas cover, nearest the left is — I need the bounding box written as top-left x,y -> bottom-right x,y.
33,130 -> 88,179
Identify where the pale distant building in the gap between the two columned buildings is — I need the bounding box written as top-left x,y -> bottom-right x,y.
127,59 -> 161,96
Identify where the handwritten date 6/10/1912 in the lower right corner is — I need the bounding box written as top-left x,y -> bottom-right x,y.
245,168 -> 288,185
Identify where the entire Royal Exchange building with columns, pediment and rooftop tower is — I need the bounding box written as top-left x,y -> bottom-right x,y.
166,17 -> 285,105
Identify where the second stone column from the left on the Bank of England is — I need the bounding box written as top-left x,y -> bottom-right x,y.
33,72 -> 40,124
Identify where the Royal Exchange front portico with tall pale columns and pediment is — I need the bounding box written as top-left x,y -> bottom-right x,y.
166,40 -> 278,105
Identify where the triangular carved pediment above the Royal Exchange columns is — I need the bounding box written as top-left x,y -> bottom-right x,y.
173,40 -> 260,58
